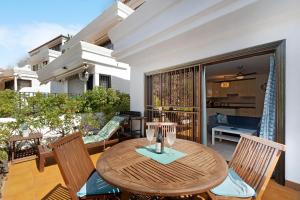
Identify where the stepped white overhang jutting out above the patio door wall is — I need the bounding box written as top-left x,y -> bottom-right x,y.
109,0 -> 257,65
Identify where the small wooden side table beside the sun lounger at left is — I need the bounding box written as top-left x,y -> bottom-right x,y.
8,133 -> 43,163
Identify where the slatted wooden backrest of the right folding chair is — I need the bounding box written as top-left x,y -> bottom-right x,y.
229,134 -> 285,199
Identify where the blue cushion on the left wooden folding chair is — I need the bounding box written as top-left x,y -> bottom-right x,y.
77,171 -> 120,197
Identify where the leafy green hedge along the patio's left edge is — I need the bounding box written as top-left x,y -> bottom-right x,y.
0,87 -> 130,159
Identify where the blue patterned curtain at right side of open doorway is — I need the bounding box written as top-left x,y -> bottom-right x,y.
259,55 -> 276,141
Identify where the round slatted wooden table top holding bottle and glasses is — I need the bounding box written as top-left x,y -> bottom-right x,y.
96,138 -> 228,196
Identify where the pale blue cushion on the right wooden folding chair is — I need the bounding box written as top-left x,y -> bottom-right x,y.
211,169 -> 255,198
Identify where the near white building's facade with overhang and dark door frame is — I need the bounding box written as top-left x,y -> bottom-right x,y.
109,0 -> 300,191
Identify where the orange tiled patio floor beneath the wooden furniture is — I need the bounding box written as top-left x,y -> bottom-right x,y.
3,154 -> 300,200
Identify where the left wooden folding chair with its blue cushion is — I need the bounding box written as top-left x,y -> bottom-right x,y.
50,132 -> 120,200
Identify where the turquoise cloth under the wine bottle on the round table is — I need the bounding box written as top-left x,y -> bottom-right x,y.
136,144 -> 186,165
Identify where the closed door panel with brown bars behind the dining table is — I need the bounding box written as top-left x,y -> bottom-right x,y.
145,66 -> 201,142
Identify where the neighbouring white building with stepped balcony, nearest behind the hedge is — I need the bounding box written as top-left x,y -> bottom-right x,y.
38,1 -> 140,93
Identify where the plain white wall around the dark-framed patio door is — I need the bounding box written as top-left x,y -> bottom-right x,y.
111,0 -> 300,183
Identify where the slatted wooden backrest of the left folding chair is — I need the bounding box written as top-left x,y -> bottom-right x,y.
50,132 -> 95,199
